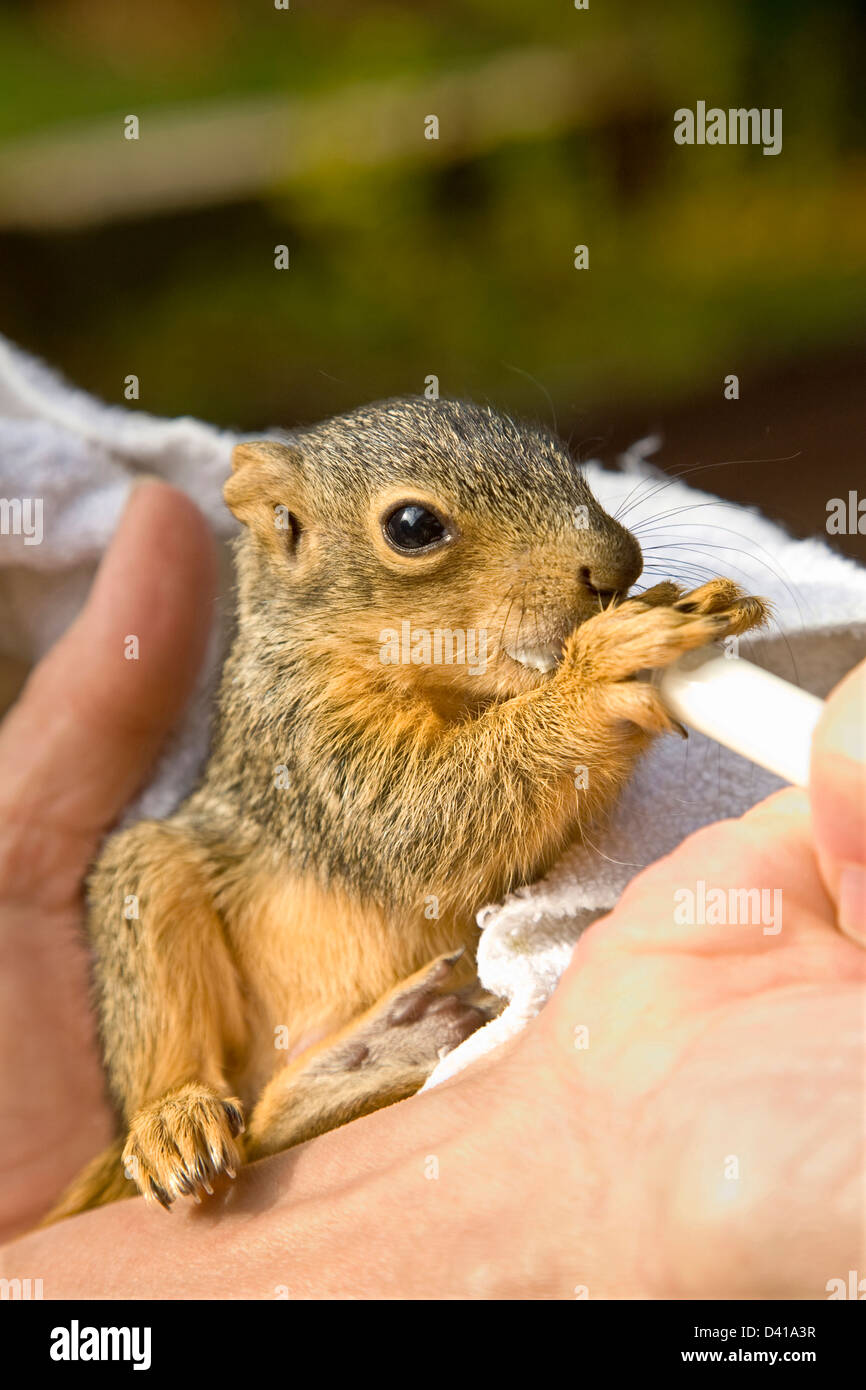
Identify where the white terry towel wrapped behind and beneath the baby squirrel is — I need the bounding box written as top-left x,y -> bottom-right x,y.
0,338 -> 866,1087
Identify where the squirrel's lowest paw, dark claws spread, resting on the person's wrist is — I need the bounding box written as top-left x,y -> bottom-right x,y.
121,1083 -> 243,1211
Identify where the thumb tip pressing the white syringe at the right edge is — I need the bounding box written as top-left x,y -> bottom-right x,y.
809,662 -> 866,945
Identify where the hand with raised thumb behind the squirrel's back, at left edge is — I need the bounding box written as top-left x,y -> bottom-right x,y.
0,482 -> 215,1238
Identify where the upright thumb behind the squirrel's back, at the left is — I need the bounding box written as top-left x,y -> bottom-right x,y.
0,482 -> 215,898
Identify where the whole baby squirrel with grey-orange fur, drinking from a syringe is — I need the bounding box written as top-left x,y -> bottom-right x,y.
49,399 -> 766,1219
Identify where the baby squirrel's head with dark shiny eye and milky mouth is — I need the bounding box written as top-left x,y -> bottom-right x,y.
225,398 -> 642,710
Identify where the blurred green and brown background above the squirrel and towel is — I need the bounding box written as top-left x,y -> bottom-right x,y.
0,0 -> 866,557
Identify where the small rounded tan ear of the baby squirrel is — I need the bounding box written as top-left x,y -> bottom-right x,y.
222,439 -> 306,550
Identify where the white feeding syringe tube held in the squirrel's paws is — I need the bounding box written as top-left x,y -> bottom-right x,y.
653,646 -> 824,787
